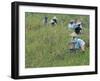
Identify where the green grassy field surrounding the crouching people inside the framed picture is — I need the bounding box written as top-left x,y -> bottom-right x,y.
25,12 -> 89,68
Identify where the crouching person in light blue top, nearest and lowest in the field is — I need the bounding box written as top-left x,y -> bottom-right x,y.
70,37 -> 85,52
